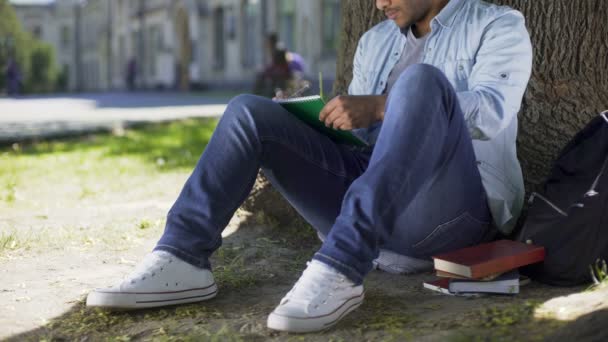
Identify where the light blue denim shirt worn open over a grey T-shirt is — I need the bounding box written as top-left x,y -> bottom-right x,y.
348,0 -> 532,234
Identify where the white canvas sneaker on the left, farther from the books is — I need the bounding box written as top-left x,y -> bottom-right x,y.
87,251 -> 217,310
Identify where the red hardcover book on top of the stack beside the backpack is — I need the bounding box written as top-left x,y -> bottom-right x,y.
433,240 -> 545,279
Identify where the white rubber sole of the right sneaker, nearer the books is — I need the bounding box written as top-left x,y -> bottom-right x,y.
267,293 -> 364,333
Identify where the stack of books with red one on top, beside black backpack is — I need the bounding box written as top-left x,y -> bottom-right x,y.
424,240 -> 545,296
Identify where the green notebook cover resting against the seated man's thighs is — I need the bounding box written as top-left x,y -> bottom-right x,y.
275,95 -> 367,146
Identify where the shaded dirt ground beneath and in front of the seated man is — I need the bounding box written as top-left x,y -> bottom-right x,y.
2,217 -> 588,341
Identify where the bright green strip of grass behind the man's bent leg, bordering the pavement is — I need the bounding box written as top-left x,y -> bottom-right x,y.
0,119 -> 217,170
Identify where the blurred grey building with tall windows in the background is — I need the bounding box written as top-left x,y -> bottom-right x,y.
13,0 -> 340,91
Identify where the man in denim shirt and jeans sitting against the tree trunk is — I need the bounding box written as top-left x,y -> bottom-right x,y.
87,0 -> 532,332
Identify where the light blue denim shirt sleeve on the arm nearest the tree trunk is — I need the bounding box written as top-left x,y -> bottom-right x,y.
457,10 -> 532,140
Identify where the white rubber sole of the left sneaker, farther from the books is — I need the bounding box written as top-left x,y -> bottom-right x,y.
87,283 -> 217,310
